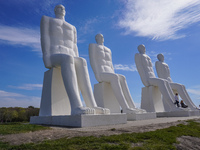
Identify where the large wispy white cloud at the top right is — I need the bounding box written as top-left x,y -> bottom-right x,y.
118,0 -> 200,40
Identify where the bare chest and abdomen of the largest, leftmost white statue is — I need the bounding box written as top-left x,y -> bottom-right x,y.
49,18 -> 76,56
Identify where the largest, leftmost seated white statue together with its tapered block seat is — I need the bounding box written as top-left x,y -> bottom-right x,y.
40,5 -> 109,116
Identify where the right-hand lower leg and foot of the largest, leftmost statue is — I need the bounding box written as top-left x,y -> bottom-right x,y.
74,57 -> 110,114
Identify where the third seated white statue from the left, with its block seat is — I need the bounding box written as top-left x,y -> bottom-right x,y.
135,45 -> 181,112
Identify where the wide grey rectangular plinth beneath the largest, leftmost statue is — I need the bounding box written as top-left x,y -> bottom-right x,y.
30,114 -> 127,128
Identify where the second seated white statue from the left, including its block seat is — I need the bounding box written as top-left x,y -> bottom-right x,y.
89,34 -> 146,114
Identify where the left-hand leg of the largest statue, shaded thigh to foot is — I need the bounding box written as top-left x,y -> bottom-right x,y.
51,54 -> 95,115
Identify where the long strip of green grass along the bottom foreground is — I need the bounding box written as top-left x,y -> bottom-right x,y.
0,121 -> 200,150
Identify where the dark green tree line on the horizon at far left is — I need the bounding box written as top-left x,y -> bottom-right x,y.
0,106 -> 40,123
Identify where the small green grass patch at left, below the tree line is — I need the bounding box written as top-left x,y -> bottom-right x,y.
0,122 -> 50,135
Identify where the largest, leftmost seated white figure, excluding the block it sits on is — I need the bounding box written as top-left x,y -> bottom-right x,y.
40,5 -> 109,116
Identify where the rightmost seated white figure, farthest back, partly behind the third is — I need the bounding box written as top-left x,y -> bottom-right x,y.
155,54 -> 197,110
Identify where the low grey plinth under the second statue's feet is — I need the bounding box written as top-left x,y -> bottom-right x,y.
127,112 -> 156,121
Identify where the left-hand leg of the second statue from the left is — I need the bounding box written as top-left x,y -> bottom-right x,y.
100,73 -> 136,113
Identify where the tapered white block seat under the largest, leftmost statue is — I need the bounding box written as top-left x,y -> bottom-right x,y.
39,68 -> 71,116
